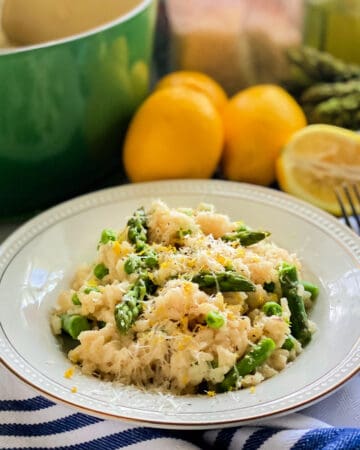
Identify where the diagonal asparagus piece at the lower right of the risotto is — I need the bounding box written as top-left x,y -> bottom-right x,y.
216,338 -> 276,392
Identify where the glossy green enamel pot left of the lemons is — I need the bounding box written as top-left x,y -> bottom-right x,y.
0,0 -> 156,218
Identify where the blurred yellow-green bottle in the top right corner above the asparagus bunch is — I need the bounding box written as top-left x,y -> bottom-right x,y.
303,0 -> 360,64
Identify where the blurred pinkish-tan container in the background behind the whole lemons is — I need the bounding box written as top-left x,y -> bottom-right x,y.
166,0 -> 302,94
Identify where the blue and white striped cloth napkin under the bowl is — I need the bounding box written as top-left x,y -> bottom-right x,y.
0,366 -> 360,450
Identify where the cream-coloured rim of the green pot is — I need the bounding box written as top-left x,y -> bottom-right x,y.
0,0 -> 153,57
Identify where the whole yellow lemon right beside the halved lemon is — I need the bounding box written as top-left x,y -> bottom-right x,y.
222,84 -> 306,186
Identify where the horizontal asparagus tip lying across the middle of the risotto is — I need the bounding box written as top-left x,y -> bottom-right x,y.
191,271 -> 256,292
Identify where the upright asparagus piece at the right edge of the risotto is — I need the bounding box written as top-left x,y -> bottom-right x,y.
279,262 -> 311,346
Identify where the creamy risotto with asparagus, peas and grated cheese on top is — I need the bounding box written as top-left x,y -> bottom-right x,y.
51,200 -> 318,395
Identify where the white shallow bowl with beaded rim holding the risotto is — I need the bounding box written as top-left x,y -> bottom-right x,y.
0,180 -> 360,429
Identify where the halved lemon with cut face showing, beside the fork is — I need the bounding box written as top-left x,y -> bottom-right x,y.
276,124 -> 360,215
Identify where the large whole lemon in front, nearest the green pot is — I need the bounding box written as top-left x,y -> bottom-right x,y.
123,87 -> 224,182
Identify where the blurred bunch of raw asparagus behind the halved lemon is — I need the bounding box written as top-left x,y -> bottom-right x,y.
285,47 -> 360,130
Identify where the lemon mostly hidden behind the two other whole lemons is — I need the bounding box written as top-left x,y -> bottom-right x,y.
156,70 -> 228,111
